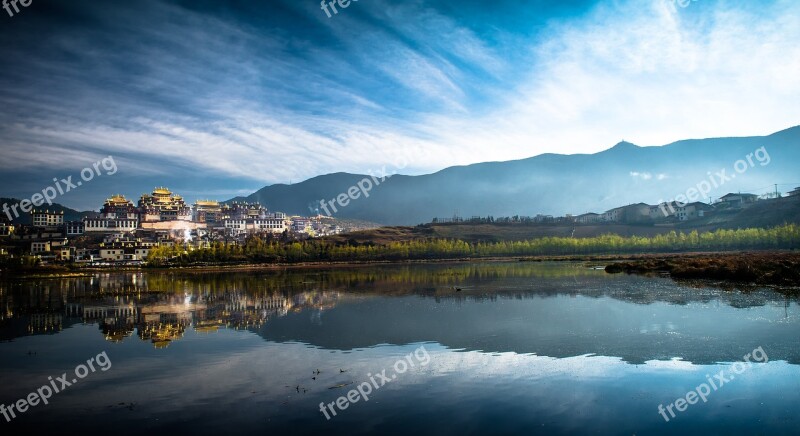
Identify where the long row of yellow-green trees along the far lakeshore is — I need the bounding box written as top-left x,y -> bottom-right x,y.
147,224 -> 800,267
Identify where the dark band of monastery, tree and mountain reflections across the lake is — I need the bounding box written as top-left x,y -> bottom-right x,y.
0,262 -> 800,363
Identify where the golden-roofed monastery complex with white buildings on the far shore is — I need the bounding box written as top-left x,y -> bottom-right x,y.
0,187 -> 344,264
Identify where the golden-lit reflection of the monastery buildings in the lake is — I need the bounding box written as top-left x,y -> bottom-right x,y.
0,276 -> 339,348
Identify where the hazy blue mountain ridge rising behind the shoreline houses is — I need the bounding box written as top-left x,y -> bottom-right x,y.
232,126 -> 800,225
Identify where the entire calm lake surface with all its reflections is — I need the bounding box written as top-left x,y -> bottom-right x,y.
0,262 -> 800,435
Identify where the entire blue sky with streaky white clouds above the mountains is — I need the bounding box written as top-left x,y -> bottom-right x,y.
0,0 -> 800,209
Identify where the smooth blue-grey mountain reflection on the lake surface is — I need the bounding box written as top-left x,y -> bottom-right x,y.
257,281 -> 800,364
